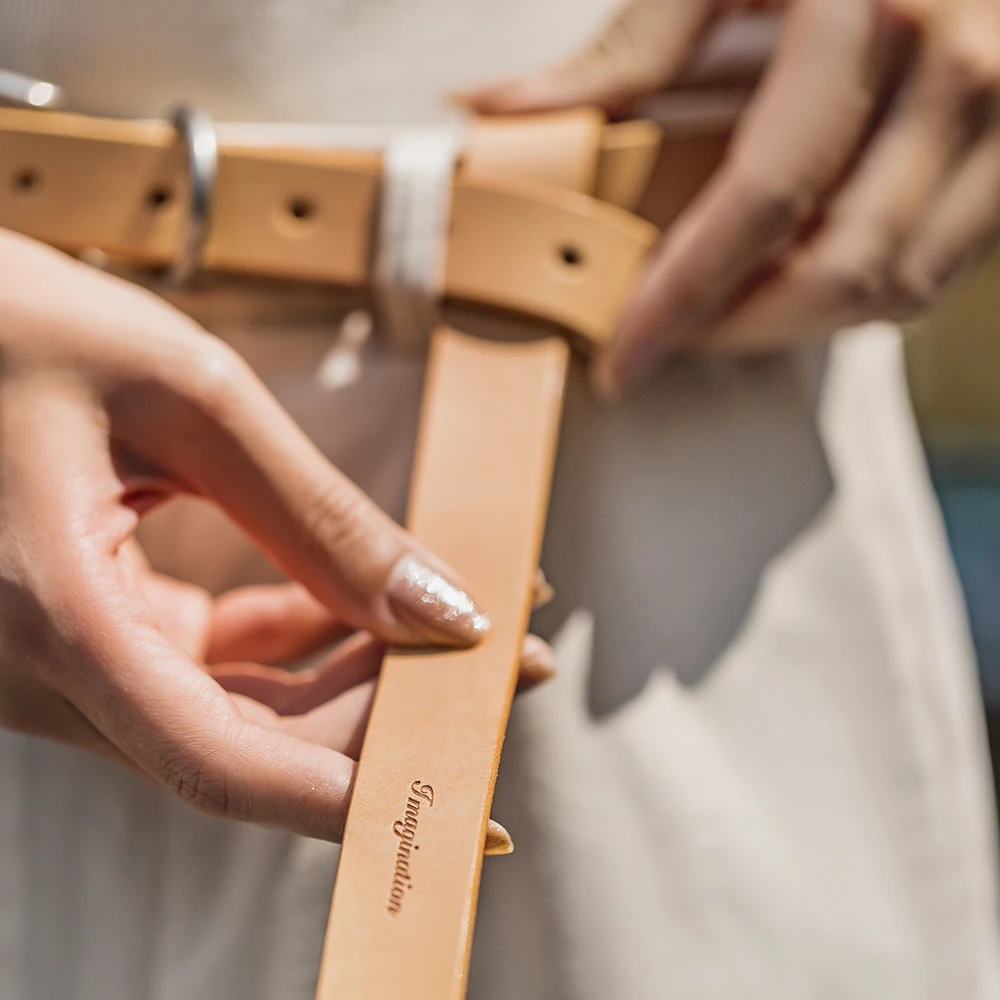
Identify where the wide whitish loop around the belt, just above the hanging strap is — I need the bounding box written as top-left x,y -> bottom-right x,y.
373,127 -> 460,351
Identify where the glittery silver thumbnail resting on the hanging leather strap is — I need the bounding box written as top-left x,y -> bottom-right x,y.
386,555 -> 490,646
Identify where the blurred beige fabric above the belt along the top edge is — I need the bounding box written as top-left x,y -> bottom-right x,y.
0,0 -> 613,125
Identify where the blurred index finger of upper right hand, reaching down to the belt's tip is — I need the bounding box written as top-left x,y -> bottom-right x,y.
596,0 -> 906,394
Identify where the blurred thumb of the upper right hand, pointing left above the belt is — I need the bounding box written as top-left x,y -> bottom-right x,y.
457,0 -> 721,114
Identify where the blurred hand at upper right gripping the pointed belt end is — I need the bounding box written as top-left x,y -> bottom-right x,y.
466,0 -> 1000,394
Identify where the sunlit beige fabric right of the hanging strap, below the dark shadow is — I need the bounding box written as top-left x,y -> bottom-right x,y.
473,328 -> 1000,1000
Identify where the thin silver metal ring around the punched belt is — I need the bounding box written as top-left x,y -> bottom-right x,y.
167,104 -> 219,288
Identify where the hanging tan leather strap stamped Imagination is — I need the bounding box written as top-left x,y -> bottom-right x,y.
317,330 -> 568,1000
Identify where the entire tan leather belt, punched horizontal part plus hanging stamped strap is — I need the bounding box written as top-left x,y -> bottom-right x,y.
0,110 -> 658,1000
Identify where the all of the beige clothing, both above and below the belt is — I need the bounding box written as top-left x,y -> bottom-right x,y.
0,0 -> 1000,1000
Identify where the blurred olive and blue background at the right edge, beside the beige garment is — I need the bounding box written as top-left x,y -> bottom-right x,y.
907,252 -> 1000,820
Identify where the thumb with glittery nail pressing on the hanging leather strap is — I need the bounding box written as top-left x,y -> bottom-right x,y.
112,324 -> 489,646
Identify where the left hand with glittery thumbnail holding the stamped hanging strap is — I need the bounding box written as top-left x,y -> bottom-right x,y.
0,233 -> 549,839
